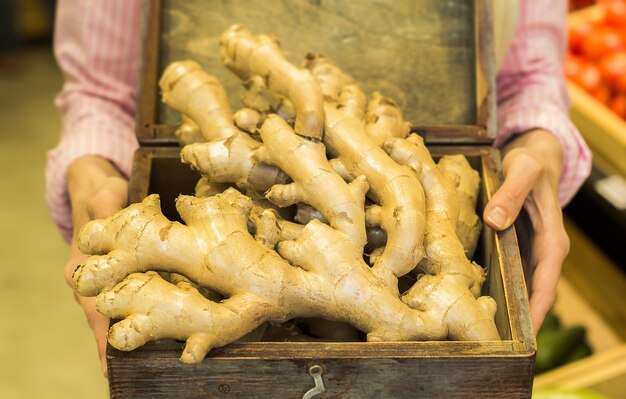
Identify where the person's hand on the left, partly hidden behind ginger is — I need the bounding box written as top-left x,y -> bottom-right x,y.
65,156 -> 128,377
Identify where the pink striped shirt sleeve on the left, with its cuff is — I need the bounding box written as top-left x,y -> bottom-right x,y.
46,0 -> 140,242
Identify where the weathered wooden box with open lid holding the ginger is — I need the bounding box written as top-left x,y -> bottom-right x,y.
107,0 -> 535,398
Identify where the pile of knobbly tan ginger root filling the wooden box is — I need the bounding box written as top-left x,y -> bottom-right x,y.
73,25 -> 500,363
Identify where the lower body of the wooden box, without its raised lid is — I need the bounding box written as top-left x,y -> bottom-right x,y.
107,146 -> 535,398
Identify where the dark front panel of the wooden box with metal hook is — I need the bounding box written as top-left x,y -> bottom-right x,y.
109,357 -> 533,399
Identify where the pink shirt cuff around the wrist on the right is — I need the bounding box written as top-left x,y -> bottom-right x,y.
494,105 -> 591,206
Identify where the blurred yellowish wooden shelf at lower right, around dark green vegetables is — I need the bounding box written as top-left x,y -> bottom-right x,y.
533,217 -> 626,398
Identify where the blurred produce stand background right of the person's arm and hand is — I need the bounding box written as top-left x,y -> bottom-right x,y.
534,0 -> 626,398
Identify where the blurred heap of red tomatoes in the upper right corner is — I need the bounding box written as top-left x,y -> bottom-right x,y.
564,0 -> 626,119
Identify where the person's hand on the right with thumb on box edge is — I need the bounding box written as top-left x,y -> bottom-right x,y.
484,129 -> 570,334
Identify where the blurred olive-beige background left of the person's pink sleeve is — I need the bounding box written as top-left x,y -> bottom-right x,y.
0,0 -> 108,399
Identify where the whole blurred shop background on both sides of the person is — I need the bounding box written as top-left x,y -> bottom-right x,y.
0,0 -> 626,398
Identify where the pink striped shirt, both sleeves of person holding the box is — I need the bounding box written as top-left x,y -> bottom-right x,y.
46,0 -> 591,242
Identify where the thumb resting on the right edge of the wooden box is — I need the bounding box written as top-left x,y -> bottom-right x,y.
483,154 -> 541,230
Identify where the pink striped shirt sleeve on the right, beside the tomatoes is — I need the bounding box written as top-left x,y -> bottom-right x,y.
495,0 -> 591,205
